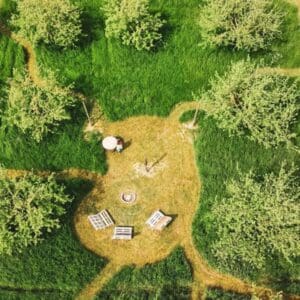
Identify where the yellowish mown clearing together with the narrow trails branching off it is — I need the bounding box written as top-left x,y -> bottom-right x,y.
0,5 -> 300,299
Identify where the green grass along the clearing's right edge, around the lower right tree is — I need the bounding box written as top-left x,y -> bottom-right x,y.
190,114 -> 300,293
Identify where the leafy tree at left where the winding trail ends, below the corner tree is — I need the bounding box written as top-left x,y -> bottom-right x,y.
4,72 -> 75,142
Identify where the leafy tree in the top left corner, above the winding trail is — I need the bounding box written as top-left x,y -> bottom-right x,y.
11,0 -> 82,48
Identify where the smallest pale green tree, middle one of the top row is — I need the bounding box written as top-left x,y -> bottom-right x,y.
103,0 -> 165,50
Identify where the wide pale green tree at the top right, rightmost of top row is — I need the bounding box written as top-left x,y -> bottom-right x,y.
199,0 -> 284,51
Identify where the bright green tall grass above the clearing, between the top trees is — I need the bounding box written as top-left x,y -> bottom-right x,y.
33,0 -> 300,120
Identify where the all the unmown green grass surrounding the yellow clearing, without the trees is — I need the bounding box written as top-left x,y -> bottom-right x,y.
0,0 -> 300,299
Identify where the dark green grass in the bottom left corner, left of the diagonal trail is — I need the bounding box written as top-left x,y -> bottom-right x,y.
0,179 -> 105,299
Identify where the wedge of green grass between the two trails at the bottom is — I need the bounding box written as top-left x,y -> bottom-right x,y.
97,248 -> 192,300
